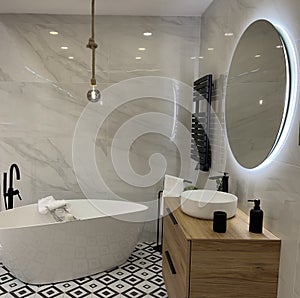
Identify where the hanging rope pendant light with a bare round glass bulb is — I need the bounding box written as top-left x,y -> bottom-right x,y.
86,0 -> 101,102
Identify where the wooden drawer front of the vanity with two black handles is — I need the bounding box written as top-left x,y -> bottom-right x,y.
163,207 -> 190,298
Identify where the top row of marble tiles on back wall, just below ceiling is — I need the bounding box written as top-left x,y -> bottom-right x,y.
0,16 -> 200,83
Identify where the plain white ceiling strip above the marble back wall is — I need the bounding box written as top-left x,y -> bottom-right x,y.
0,0 -> 213,16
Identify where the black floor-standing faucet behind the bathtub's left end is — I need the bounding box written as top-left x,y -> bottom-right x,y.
3,163 -> 22,210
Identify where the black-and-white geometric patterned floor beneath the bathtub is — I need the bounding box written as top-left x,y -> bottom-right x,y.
0,242 -> 168,298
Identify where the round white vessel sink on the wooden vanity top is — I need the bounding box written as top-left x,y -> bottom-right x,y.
180,189 -> 238,219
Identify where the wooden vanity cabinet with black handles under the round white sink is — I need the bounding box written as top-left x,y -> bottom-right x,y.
162,198 -> 281,298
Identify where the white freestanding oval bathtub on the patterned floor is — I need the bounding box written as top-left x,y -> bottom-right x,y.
0,200 -> 147,284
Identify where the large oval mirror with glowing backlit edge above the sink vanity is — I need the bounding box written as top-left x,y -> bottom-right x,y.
225,20 -> 290,169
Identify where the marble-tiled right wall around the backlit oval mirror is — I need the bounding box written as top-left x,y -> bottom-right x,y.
200,0 -> 300,298
